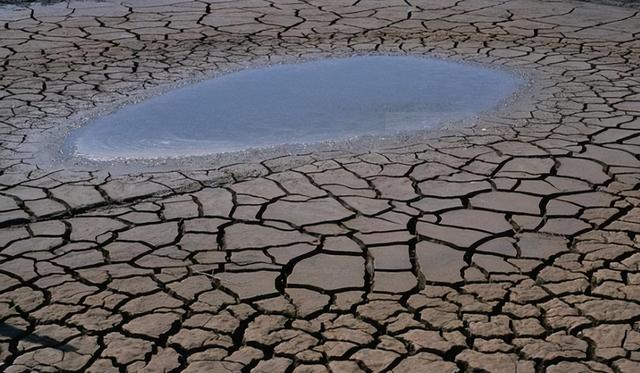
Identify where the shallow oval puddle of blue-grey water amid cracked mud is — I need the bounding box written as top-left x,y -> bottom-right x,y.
63,56 -> 523,161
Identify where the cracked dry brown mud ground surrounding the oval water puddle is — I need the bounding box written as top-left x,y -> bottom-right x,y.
0,0 -> 640,373
